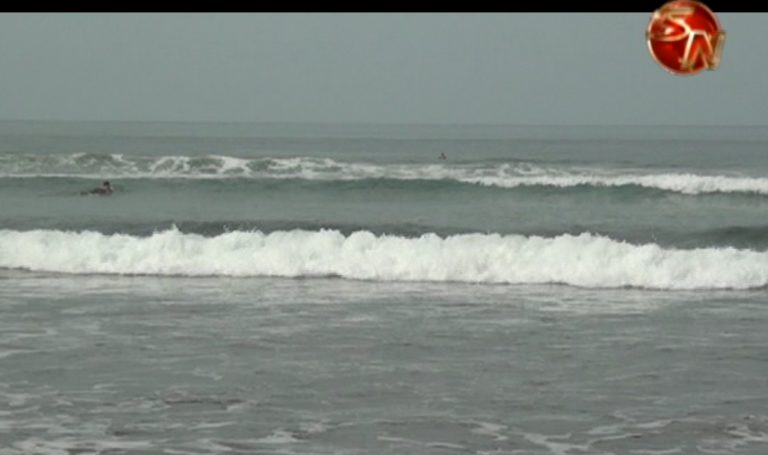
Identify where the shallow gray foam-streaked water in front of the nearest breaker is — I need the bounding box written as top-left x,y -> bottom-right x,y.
0,273 -> 768,454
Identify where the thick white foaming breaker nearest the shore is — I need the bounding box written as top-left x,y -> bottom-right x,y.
0,229 -> 768,289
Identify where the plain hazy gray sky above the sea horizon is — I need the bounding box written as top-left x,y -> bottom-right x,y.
0,12 -> 768,125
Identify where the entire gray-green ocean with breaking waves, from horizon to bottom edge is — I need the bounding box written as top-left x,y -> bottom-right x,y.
0,121 -> 768,455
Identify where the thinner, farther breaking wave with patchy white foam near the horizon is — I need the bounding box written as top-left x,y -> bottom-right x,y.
0,154 -> 768,195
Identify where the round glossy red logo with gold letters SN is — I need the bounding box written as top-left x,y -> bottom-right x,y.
645,0 -> 725,75
